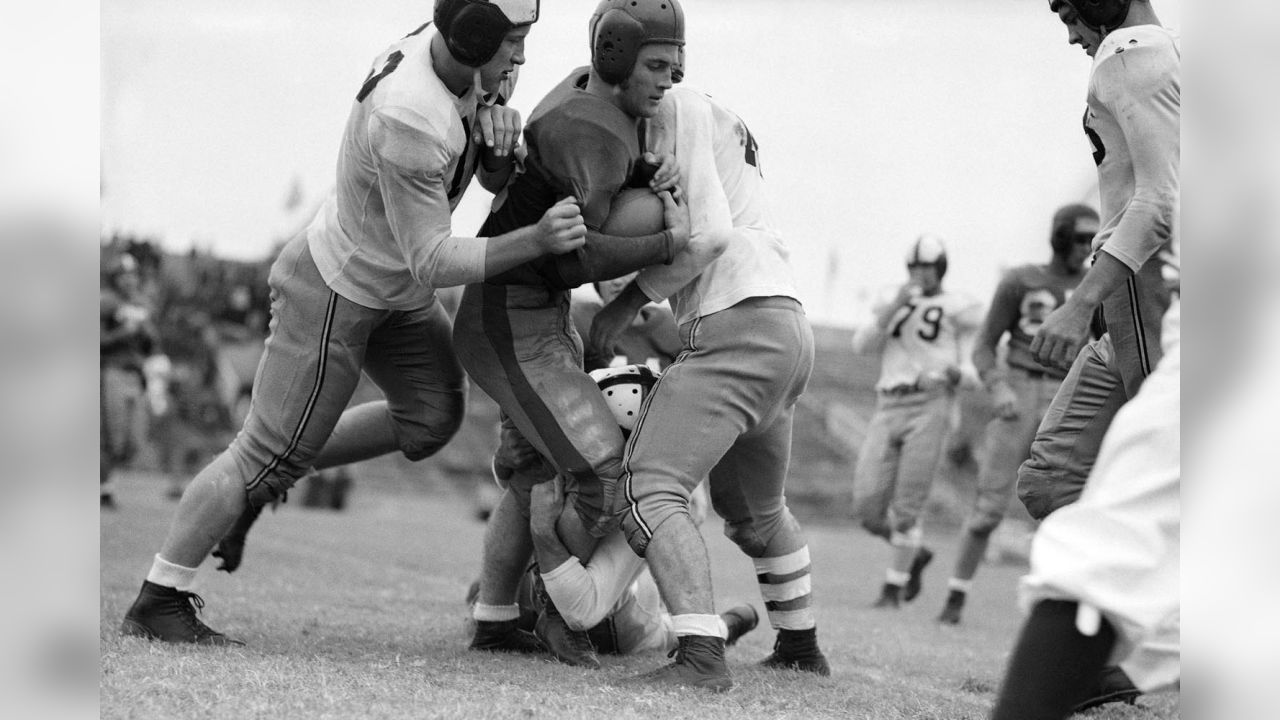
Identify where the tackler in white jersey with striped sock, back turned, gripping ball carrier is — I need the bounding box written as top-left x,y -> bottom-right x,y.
591,83 -> 831,691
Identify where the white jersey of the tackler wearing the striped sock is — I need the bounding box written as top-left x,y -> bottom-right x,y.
637,87 -> 796,324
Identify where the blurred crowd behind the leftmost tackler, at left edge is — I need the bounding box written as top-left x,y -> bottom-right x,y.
99,234 -> 270,506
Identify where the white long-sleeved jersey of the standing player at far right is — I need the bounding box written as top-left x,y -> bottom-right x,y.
1084,26 -> 1181,272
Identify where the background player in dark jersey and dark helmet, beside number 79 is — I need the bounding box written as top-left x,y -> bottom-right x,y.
938,205 -> 1098,625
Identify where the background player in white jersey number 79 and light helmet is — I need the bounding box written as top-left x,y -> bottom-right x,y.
854,234 -> 982,607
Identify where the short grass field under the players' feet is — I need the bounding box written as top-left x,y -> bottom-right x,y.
100,473 -> 1180,720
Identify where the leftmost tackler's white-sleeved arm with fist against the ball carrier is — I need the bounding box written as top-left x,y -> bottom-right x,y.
370,107 -> 585,288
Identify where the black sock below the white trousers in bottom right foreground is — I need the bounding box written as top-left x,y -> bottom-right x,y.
991,600 -> 1116,720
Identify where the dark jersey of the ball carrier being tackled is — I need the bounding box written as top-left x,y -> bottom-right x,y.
480,68 -> 653,288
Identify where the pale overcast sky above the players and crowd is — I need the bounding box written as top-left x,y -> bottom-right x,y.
101,0 -> 1180,325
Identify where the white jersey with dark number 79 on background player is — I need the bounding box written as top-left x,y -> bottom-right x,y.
854,285 -> 982,389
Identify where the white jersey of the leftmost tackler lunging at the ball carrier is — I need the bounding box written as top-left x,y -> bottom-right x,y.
307,26 -> 511,310
